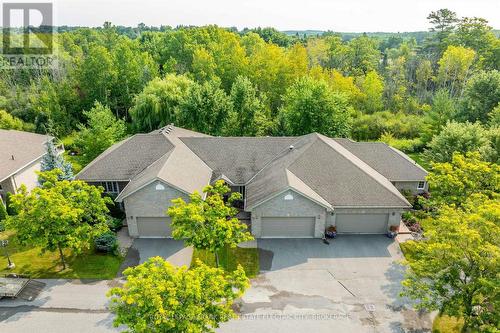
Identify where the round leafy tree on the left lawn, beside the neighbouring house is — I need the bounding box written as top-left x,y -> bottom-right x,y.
7,169 -> 111,269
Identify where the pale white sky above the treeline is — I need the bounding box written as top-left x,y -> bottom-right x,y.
49,0 -> 500,32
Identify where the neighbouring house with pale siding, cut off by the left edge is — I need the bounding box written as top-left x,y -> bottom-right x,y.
0,129 -> 54,201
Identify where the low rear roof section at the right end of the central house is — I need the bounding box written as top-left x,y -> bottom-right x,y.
335,139 -> 427,181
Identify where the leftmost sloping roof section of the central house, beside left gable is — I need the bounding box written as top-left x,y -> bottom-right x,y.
76,133 -> 174,181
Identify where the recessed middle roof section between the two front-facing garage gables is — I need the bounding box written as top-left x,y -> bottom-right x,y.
180,137 -> 297,184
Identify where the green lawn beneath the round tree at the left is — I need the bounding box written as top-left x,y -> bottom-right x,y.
0,232 -> 123,279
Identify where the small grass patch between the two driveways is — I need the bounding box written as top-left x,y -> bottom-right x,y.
191,247 -> 259,278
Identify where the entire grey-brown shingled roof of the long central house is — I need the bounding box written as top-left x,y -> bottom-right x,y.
79,126 -> 418,208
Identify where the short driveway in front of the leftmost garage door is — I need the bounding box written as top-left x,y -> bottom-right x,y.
119,238 -> 193,275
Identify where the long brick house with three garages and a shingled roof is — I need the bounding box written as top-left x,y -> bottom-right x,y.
77,125 -> 427,238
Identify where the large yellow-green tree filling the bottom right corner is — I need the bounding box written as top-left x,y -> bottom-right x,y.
403,195 -> 500,332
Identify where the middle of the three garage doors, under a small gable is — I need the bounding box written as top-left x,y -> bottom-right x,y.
262,217 -> 315,238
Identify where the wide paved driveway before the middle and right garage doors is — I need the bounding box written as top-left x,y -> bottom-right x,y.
219,235 -> 431,333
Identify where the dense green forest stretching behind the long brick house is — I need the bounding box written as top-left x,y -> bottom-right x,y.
0,9 -> 500,170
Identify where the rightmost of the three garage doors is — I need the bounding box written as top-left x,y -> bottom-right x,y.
335,214 -> 389,234
